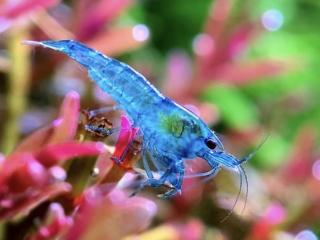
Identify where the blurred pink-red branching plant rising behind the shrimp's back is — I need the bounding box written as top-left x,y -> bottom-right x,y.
164,0 -> 289,106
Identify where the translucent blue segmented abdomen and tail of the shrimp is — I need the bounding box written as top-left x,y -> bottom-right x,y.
25,40 -> 163,120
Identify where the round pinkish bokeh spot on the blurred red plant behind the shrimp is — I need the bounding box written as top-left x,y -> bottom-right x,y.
192,33 -> 214,56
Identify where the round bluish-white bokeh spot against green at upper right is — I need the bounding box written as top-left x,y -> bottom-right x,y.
261,9 -> 284,32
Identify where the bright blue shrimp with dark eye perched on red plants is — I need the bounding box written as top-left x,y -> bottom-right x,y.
25,40 -> 252,197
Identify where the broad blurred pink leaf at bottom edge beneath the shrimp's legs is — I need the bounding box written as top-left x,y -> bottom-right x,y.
66,188 -> 156,240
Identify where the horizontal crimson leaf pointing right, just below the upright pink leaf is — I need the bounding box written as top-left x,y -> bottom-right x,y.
35,142 -> 106,167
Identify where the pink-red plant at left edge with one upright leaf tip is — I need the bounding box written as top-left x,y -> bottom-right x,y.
0,92 -> 105,219
